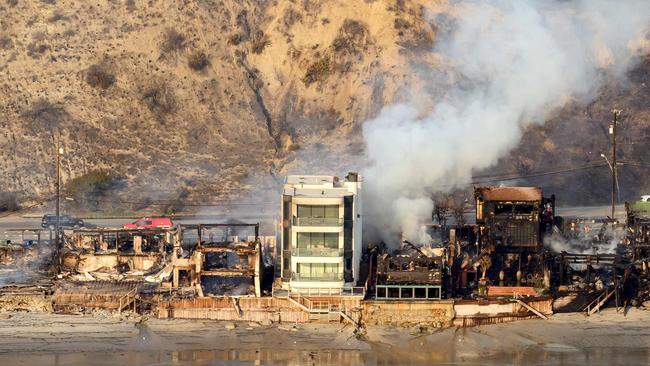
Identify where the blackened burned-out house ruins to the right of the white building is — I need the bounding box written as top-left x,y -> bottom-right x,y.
368,187 -> 650,313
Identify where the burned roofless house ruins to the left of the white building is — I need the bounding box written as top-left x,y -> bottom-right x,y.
33,223 -> 273,313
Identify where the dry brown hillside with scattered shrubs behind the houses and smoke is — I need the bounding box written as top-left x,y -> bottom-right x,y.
0,0 -> 650,213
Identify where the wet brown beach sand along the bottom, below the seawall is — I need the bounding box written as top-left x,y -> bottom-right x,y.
0,309 -> 650,365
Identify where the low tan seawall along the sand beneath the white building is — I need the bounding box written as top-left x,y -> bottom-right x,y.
158,297 -> 552,328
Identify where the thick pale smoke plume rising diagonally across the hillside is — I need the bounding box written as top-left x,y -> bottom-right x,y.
363,0 -> 650,241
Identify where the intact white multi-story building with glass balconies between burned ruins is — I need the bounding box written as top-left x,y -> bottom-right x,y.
280,173 -> 362,291
